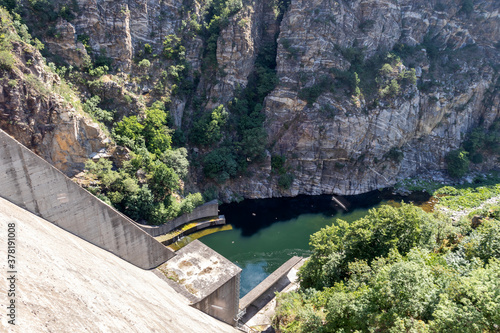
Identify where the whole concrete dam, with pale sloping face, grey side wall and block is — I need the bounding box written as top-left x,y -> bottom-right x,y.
0,130 -> 241,333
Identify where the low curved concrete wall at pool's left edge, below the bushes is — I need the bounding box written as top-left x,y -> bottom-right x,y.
137,200 -> 219,237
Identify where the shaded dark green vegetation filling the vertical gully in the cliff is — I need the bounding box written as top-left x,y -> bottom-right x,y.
188,0 -> 293,187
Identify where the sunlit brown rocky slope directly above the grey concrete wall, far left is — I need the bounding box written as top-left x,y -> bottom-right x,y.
0,12 -> 111,176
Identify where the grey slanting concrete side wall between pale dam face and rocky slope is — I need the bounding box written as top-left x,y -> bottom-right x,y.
0,130 -> 174,269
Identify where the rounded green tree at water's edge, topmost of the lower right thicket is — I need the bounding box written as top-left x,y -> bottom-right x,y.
299,203 -> 438,289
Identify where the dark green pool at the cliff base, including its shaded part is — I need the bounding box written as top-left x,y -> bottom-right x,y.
200,191 -> 425,297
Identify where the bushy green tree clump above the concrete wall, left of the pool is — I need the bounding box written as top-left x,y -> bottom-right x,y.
85,102 -> 203,224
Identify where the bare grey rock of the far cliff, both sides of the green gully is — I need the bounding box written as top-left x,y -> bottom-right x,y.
3,0 -> 500,199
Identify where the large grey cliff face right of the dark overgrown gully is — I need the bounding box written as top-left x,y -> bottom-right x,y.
219,0 -> 500,197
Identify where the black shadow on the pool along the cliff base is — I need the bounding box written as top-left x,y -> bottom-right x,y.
220,190 -> 430,237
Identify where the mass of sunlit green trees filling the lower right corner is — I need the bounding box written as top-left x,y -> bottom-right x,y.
274,191 -> 500,332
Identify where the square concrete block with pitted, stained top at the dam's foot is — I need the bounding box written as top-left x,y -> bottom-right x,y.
158,240 -> 241,325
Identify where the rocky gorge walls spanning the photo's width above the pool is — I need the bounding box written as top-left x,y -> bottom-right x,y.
0,0 -> 500,201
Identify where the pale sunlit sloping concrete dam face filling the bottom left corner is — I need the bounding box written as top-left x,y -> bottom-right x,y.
0,198 -> 238,333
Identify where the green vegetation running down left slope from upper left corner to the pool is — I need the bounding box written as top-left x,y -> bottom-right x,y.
0,7 -> 204,224
